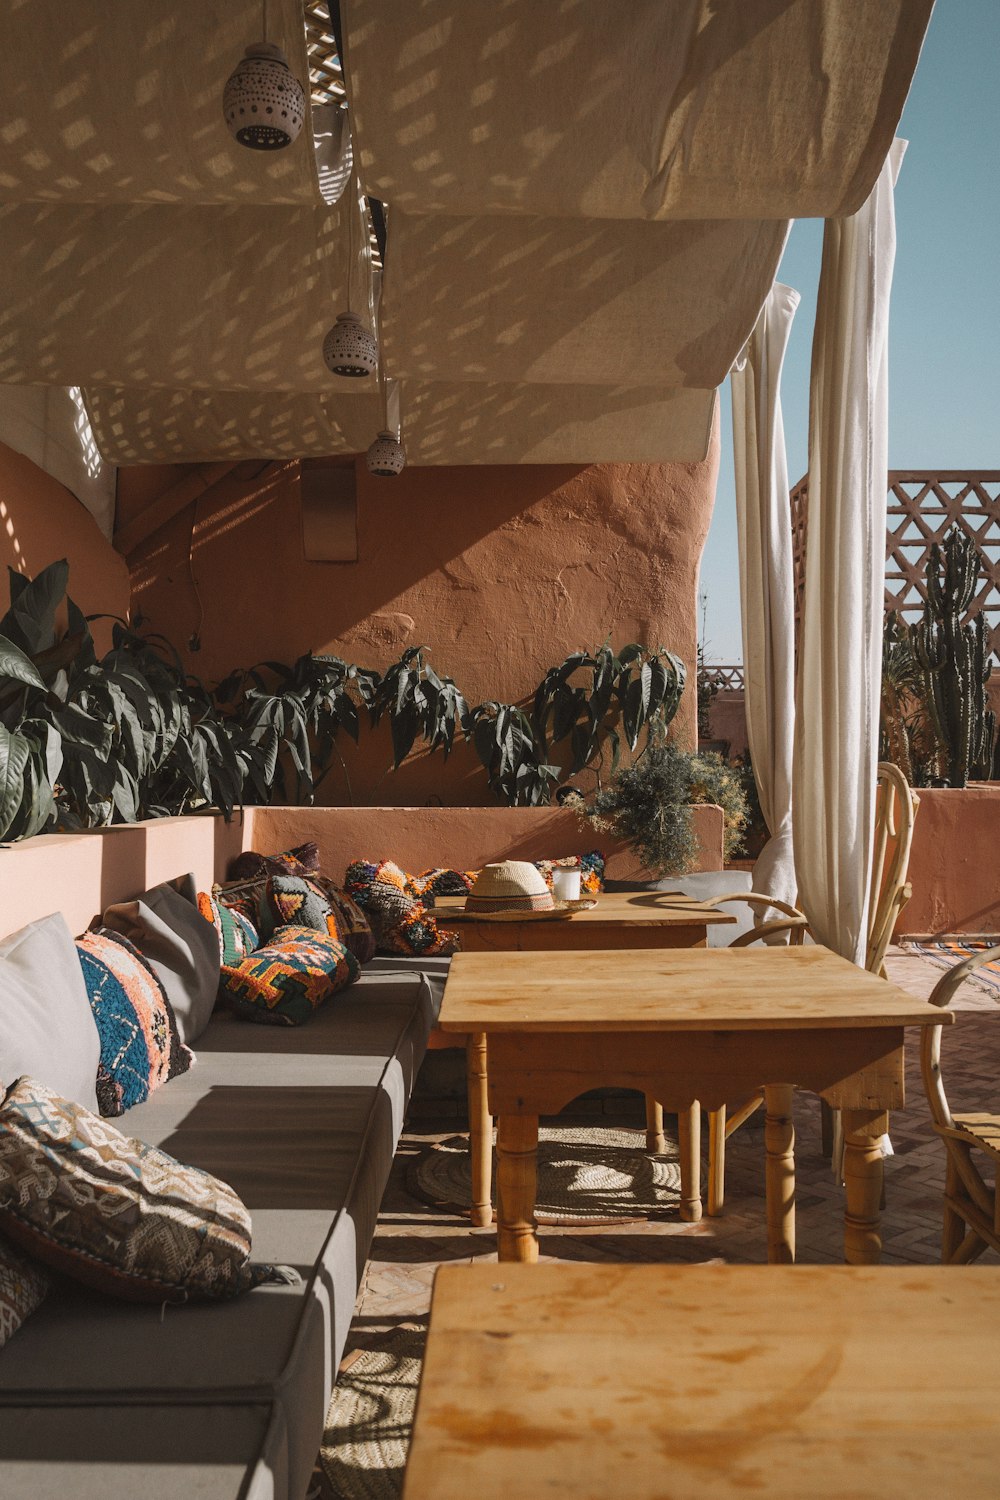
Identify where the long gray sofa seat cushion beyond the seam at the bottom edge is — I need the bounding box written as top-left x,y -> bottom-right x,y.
0,972 -> 430,1496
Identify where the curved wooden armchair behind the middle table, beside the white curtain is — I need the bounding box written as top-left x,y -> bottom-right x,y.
706,761 -> 921,1217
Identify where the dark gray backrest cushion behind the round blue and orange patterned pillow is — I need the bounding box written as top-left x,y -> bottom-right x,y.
103,876 -> 220,1047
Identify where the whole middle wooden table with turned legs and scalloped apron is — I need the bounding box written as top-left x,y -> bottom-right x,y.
438,945 -> 952,1265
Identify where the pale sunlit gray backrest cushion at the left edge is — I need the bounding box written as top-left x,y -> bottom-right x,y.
0,912 -> 100,1115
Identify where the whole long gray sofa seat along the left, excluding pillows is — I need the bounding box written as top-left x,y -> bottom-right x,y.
0,959 -> 447,1500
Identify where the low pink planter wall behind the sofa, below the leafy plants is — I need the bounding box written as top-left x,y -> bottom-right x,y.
0,804 -> 723,938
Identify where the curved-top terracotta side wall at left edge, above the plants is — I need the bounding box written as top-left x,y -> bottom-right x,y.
0,443 -> 129,650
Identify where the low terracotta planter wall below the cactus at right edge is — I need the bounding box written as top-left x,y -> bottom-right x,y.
897,782 -> 1000,935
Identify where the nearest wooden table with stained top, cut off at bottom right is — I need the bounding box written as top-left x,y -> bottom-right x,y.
403,1263 -> 1000,1500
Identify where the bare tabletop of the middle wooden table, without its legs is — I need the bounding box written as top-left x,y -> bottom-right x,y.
438,944 -> 954,1034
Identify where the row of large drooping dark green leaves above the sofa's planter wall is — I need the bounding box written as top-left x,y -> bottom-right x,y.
0,563 -> 695,839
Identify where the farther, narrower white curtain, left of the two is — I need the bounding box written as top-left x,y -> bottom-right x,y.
730,282 -> 799,902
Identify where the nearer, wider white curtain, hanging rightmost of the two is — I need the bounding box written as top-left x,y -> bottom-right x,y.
793,141 -> 906,965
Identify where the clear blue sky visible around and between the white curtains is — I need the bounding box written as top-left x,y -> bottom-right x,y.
699,0 -> 1000,662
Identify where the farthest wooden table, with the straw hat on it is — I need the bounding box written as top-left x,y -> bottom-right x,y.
430,891 -> 736,1229
